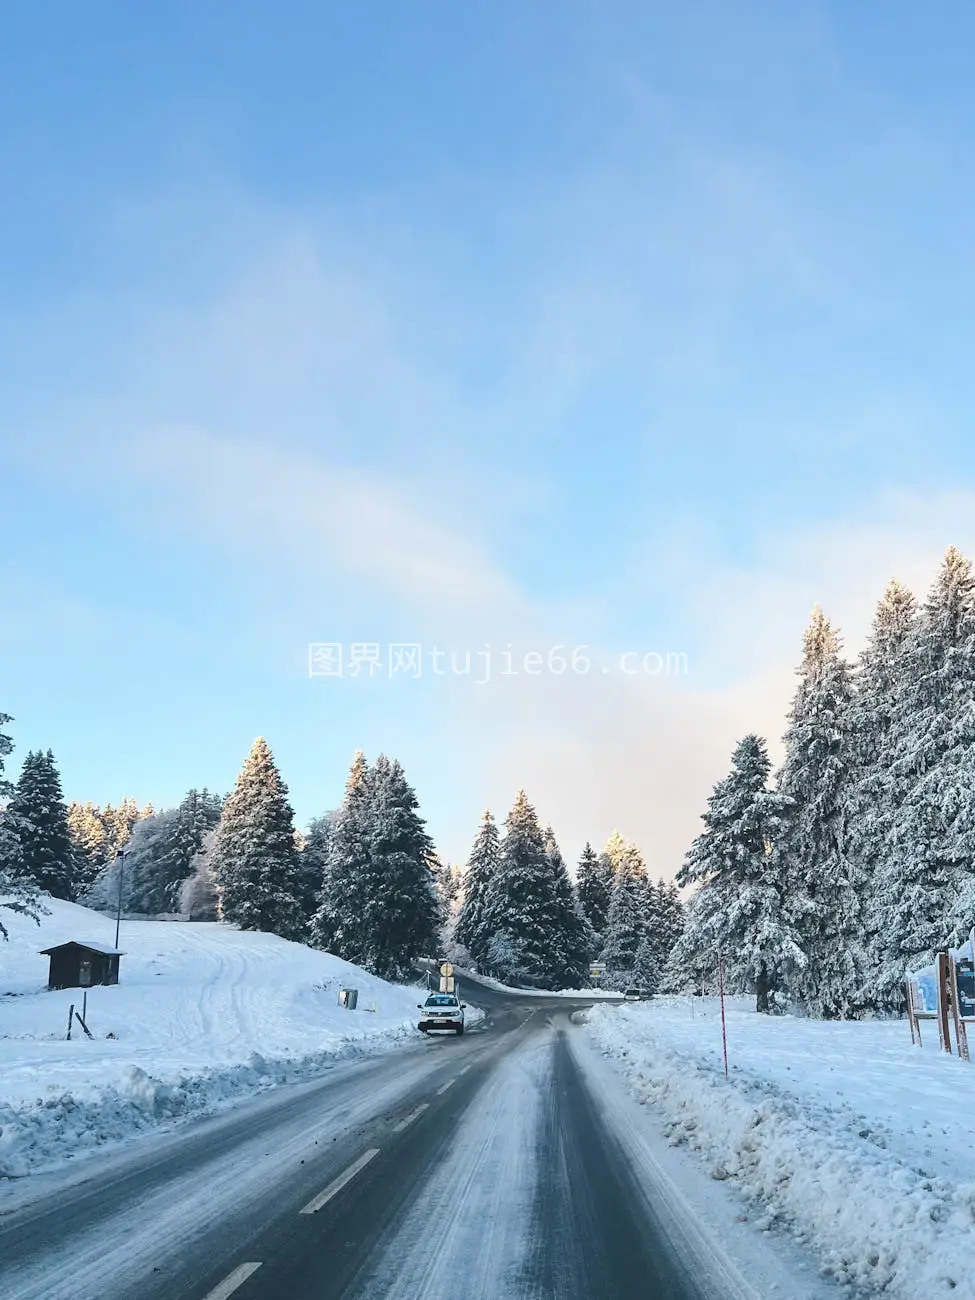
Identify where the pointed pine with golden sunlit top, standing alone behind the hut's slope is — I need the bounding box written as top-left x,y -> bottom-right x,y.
211,737 -> 304,939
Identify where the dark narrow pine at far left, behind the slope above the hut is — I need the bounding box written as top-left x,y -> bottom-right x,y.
9,750 -> 78,902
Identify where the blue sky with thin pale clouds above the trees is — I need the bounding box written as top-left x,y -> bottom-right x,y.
0,0 -> 975,875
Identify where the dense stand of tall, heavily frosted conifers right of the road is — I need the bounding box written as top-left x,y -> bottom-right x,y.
668,547 -> 975,1018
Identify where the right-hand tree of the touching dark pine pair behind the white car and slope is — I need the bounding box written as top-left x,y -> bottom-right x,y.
361,754 -> 441,979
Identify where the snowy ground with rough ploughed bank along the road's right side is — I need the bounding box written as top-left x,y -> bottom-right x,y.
586,998 -> 975,1300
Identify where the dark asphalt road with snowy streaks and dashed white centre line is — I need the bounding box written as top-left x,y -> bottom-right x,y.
0,983 -> 790,1300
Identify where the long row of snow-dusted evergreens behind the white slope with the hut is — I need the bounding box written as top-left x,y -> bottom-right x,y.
0,719 -> 683,989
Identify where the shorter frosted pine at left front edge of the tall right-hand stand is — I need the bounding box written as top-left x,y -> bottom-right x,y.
662,735 -> 805,1011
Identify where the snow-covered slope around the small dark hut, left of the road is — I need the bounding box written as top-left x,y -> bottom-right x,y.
0,900 -> 441,1177
